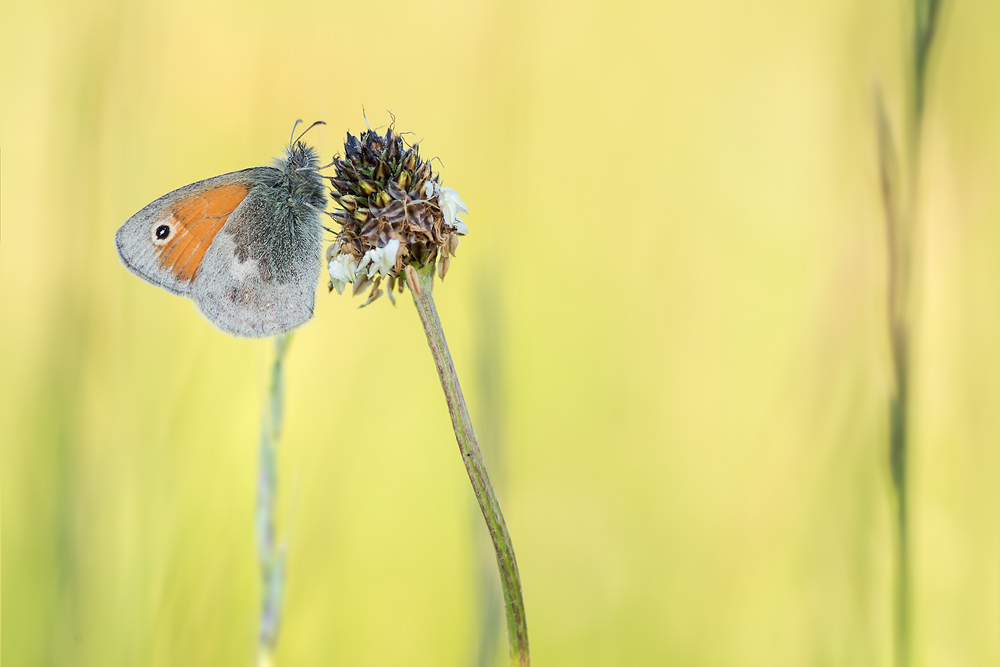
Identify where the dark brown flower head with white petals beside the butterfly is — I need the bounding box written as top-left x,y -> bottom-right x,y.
327,118 -> 469,305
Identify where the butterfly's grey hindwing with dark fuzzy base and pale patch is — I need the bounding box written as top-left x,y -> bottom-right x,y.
191,183 -> 322,338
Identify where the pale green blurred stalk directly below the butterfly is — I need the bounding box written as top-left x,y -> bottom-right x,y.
256,333 -> 292,667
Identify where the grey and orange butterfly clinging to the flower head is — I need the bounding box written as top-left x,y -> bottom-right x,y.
115,121 -> 327,338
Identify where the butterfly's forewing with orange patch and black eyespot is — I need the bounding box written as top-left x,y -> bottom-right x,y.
115,167 -> 276,295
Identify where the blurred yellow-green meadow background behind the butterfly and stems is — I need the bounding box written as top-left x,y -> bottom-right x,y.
0,0 -> 1000,667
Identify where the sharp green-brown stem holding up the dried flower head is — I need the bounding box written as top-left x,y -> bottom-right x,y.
410,262 -> 531,667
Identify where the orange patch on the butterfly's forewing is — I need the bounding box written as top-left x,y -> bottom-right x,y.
153,183 -> 250,282
